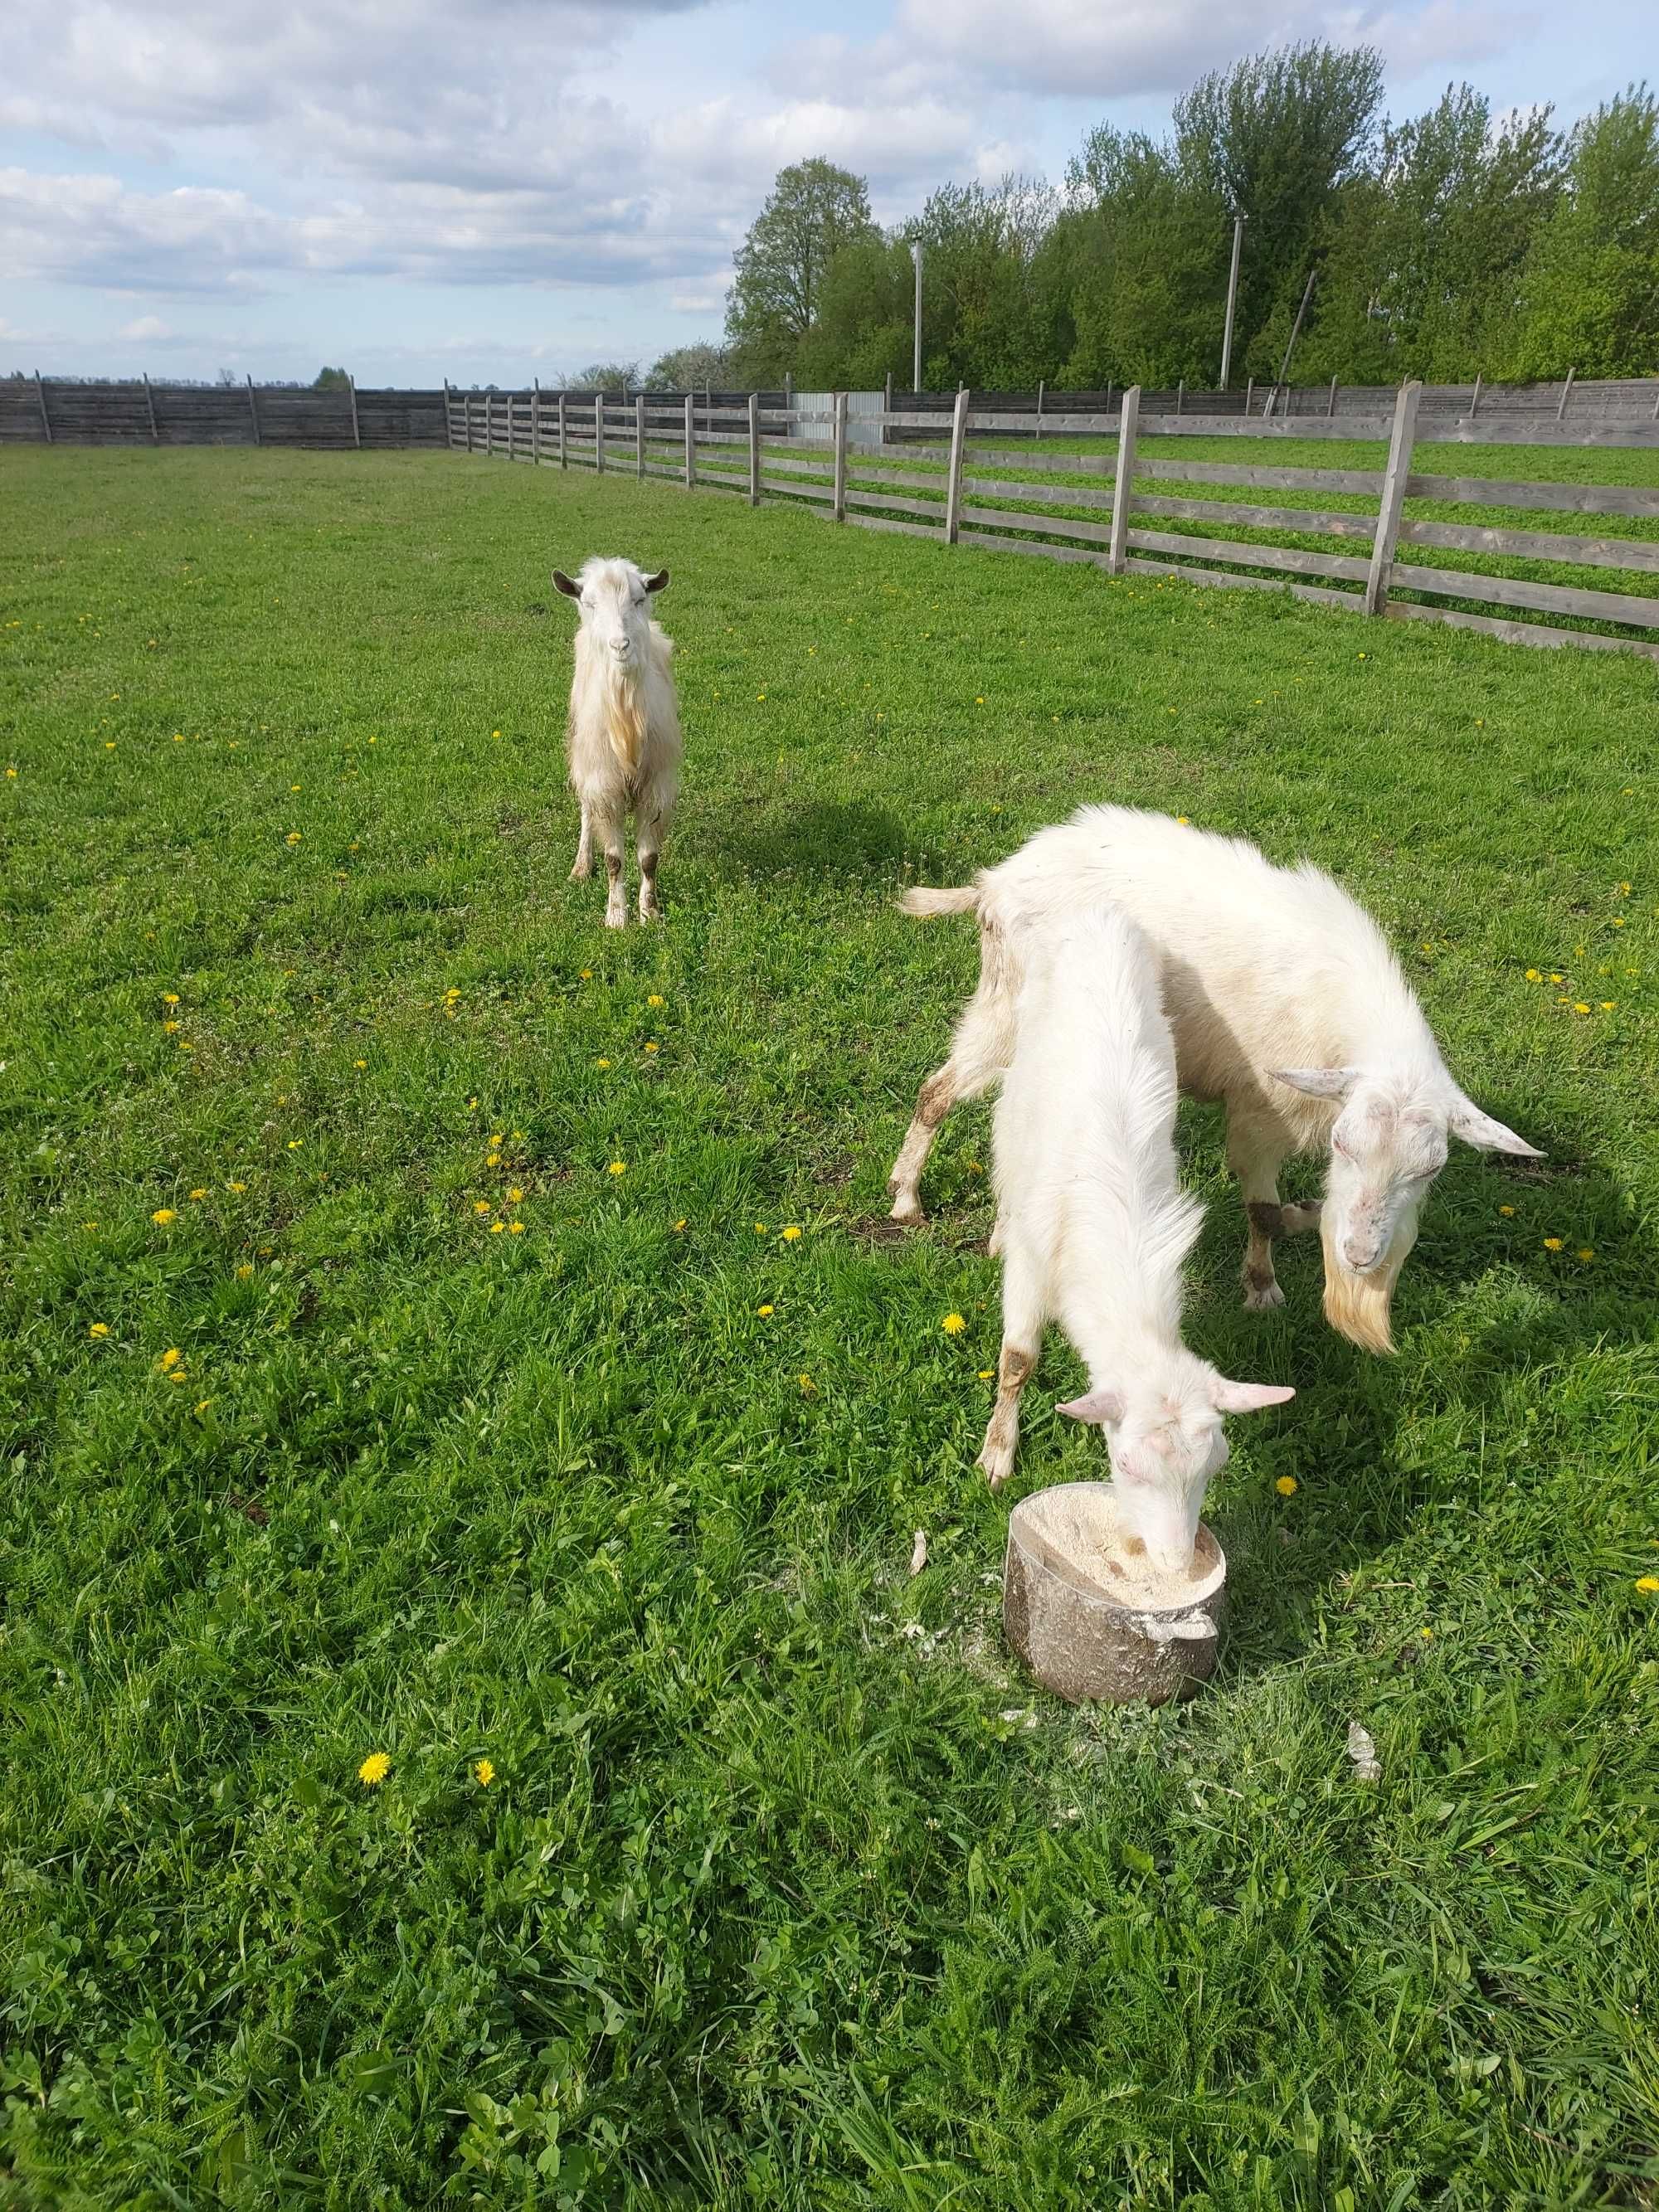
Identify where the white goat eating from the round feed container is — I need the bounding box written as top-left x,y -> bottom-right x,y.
980,905 -> 1297,1573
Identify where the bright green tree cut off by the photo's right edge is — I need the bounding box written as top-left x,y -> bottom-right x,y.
1506,84 -> 1659,378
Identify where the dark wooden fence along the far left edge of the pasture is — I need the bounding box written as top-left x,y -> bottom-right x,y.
0,376 -> 447,449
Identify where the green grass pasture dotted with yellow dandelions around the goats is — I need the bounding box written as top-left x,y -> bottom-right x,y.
0,451 -> 1659,2212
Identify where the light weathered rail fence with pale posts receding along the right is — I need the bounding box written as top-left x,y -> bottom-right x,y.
449,385 -> 1659,659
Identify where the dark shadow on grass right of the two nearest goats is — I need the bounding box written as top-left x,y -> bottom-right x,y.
1188,1121 -> 1659,1681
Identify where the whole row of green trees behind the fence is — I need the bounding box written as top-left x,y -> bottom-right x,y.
641,42 -> 1659,391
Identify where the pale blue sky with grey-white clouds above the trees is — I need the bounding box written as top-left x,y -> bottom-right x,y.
0,0 -> 1655,385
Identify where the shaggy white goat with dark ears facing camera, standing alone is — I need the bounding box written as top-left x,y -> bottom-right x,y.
553,557 -> 681,929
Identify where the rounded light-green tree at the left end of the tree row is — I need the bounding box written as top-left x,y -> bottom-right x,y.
726,159 -> 878,382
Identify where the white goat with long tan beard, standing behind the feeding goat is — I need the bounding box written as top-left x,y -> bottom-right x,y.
892,807 -> 1540,1352
